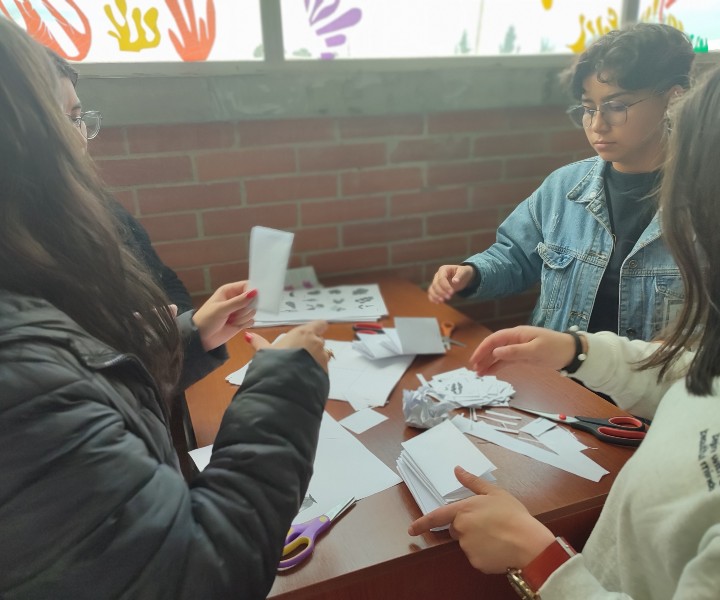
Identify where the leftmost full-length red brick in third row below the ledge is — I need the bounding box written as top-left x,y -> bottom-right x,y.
137,181 -> 240,215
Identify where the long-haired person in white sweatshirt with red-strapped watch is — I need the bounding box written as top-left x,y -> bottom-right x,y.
409,64 -> 720,600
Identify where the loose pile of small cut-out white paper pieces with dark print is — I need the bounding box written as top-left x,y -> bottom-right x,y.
428,367 -> 515,407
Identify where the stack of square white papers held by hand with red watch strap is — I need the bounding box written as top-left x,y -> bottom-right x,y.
397,421 -> 495,528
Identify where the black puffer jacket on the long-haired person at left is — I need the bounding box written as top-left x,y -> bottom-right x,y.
0,290 -> 328,600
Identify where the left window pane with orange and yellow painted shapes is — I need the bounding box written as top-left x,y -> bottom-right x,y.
0,0 -> 263,63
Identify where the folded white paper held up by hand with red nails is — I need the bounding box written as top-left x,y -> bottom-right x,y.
249,226 -> 295,314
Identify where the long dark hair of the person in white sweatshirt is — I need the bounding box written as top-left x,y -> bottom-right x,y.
641,68 -> 720,396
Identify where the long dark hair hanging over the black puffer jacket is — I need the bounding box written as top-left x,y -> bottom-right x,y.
0,18 -> 181,394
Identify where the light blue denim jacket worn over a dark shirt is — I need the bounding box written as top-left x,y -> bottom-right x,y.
464,157 -> 685,340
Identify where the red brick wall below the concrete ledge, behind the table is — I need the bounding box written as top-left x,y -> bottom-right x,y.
90,107 -> 590,327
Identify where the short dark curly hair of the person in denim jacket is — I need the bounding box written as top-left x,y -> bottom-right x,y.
562,23 -> 695,100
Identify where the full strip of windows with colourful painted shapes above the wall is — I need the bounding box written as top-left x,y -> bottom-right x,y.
0,0 -> 720,64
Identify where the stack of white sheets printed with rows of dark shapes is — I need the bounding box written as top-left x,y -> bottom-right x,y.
255,283 -> 388,327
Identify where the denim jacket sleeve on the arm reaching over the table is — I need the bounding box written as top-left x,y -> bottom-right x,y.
464,192 -> 543,299
